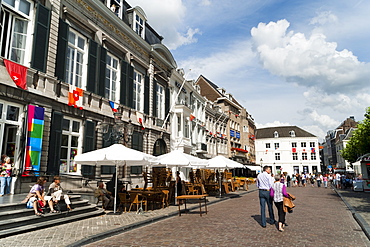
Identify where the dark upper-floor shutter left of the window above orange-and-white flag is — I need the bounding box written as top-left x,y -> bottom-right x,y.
55,19 -> 69,81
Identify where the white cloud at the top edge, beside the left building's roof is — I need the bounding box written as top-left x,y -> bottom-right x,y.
128,0 -> 202,50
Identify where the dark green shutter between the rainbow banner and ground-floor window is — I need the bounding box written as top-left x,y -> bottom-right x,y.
47,112 -> 63,175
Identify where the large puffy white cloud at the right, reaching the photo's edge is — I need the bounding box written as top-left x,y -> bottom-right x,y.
251,20 -> 370,94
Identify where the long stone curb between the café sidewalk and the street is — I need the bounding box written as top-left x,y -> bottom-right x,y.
67,189 -> 257,247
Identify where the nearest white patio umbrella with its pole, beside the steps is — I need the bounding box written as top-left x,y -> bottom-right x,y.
74,144 -> 156,213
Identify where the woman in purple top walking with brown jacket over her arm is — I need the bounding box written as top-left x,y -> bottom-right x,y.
270,175 -> 289,232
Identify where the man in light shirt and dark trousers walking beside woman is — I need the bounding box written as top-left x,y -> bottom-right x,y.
257,166 -> 276,228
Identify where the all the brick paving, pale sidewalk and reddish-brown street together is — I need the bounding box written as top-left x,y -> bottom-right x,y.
0,187 -> 370,247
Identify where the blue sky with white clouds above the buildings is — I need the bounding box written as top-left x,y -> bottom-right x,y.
127,0 -> 370,141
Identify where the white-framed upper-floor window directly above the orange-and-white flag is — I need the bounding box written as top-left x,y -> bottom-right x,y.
66,28 -> 87,89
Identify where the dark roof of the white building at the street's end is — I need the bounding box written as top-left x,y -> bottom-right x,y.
256,126 -> 316,139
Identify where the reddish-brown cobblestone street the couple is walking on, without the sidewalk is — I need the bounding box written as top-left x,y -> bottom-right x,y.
88,187 -> 370,247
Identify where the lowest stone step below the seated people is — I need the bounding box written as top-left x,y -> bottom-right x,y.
0,205 -> 104,237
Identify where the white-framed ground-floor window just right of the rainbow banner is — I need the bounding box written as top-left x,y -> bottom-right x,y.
59,116 -> 83,174
